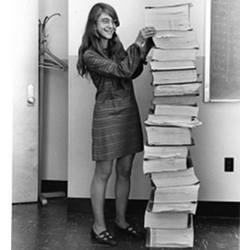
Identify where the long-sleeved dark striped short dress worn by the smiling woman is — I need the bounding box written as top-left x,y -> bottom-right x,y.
83,44 -> 146,161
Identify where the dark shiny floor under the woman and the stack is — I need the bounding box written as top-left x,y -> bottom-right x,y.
11,199 -> 239,250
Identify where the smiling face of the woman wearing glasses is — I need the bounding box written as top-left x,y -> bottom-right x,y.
97,13 -> 116,39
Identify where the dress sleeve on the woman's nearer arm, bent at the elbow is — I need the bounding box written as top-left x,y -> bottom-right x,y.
83,44 -> 141,78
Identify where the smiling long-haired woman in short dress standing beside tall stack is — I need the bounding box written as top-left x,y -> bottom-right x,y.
77,3 -> 155,245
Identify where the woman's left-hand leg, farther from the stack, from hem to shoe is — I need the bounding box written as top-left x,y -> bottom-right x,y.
90,160 -> 113,234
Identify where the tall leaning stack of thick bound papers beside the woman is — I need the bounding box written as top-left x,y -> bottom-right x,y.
143,0 -> 201,248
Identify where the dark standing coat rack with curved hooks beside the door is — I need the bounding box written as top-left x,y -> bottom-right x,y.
39,13 -> 68,205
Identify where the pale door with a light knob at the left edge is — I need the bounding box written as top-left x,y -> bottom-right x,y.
12,0 -> 39,203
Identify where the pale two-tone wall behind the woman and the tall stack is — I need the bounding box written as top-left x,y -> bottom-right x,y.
68,0 -> 240,201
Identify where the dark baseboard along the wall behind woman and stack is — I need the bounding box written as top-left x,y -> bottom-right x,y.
68,198 -> 240,218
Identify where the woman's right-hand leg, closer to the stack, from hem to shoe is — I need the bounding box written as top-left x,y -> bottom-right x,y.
115,154 -> 135,228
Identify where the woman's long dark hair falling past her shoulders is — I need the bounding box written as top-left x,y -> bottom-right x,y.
77,3 -> 122,77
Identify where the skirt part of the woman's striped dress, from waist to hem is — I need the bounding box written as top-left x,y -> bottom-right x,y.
92,96 -> 143,161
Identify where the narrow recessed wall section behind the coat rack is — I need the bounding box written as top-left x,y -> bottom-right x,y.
39,0 -> 68,180
